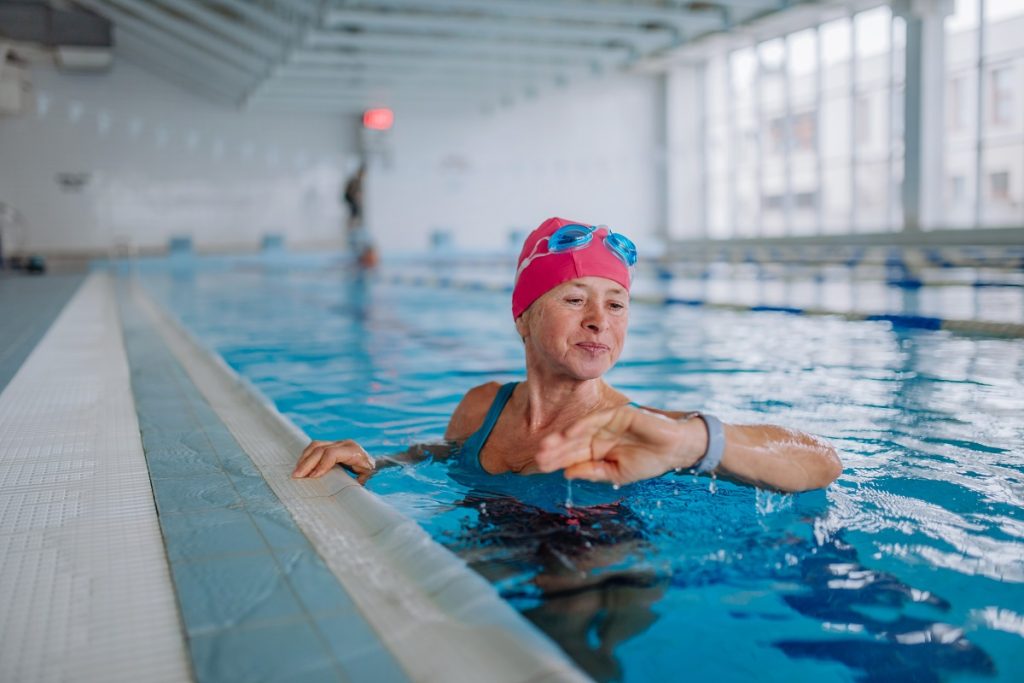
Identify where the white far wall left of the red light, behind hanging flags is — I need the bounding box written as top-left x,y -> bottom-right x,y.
0,60 -> 357,253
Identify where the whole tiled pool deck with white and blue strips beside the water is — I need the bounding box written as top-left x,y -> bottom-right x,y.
0,273 -> 585,682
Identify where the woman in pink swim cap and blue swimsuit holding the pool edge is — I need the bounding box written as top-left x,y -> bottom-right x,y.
293,218 -> 842,492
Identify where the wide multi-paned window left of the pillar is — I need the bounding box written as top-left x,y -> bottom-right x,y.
706,6 -> 904,238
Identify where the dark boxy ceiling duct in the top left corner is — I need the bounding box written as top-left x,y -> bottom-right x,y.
0,0 -> 114,71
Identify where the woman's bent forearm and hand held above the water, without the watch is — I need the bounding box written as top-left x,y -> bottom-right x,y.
537,405 -> 843,492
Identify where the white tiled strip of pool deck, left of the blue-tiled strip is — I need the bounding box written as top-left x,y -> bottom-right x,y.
0,275 -> 190,681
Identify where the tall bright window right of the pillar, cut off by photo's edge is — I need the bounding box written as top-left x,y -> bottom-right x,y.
939,0 -> 1024,227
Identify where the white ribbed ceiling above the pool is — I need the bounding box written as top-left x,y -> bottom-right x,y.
75,0 -> 795,112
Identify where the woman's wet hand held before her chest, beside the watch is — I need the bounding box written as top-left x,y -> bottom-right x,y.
536,405 -> 708,484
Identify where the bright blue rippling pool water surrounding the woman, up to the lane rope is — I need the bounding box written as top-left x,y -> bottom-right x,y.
134,258 -> 1024,681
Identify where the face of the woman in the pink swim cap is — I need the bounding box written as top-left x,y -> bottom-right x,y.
516,278 -> 630,380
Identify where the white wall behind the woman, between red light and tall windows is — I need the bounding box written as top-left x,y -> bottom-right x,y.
367,76 -> 664,250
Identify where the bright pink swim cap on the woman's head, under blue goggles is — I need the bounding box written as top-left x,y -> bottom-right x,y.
512,218 -> 630,318
